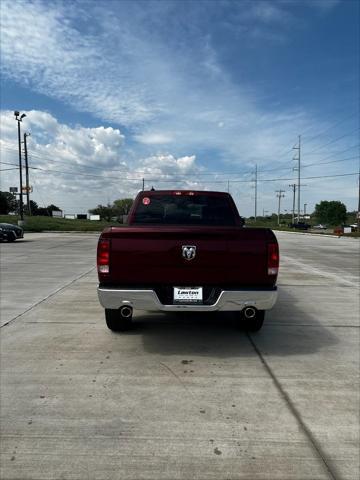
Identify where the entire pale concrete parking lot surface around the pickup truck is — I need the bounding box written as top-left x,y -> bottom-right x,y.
0,233 -> 360,480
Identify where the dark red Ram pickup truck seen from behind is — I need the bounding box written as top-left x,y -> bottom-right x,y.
97,190 -> 279,331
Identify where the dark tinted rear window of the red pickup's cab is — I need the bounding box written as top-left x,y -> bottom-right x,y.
132,195 -> 236,226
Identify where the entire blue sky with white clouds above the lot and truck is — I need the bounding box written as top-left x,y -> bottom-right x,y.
0,0 -> 360,216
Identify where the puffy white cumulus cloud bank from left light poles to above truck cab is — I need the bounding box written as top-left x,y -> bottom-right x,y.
0,110 -> 200,213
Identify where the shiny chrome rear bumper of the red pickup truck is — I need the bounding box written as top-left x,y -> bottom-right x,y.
97,287 -> 277,312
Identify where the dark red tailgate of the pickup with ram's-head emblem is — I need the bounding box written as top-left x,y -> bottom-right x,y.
101,226 -> 276,287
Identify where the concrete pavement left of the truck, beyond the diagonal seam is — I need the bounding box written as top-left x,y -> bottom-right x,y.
0,233 -> 99,325
